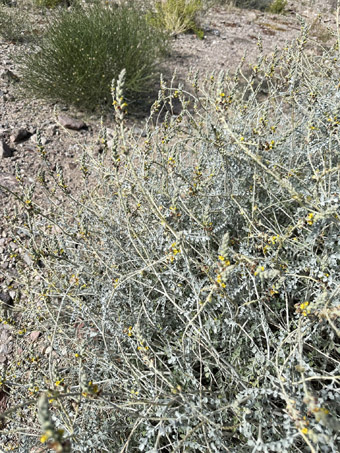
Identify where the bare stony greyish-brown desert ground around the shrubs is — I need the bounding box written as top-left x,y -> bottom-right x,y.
0,0 -> 336,434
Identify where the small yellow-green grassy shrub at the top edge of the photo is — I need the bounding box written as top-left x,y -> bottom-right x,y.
148,0 -> 203,34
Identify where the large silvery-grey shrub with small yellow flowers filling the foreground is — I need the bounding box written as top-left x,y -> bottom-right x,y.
1,29 -> 340,453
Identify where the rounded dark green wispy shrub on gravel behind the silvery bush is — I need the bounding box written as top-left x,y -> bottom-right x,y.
17,3 -> 166,109
